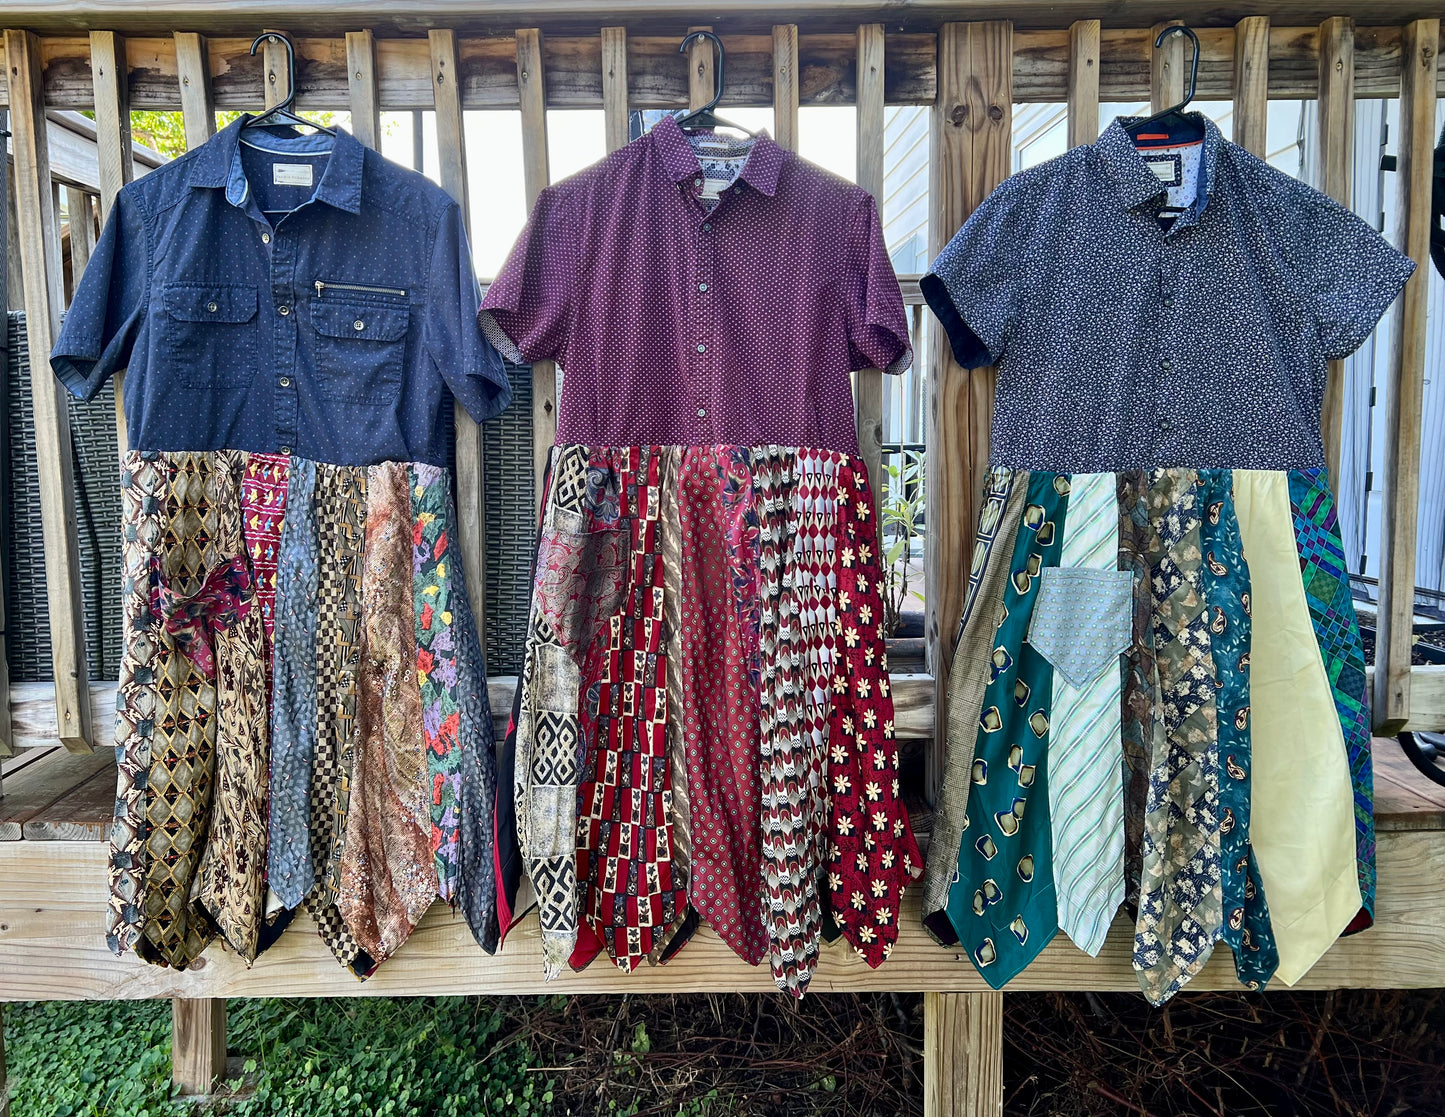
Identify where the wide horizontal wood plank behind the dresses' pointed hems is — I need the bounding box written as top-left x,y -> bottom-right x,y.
0,831 -> 1445,1001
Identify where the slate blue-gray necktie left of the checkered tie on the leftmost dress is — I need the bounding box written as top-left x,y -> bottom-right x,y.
267,458 -> 316,907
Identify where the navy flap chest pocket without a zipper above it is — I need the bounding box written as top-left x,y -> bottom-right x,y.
165,283 -> 257,389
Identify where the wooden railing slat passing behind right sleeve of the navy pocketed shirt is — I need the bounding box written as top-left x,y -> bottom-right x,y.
430,29 -> 487,640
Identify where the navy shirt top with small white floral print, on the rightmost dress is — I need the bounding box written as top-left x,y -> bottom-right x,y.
923,114 -> 1415,473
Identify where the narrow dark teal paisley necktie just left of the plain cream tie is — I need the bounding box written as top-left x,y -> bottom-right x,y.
1199,470 -> 1279,988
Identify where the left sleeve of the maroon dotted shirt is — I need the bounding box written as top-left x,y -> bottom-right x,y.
481,186 -> 578,361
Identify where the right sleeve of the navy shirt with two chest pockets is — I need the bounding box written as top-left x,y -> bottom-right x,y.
422,202 -> 512,423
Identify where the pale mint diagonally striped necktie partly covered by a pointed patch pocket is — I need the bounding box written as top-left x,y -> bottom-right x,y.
1049,473 -> 1129,955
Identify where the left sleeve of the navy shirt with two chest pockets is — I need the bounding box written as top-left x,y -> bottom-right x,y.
51,191 -> 150,399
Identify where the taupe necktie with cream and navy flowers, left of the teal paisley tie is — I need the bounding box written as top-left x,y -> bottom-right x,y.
1134,470 -> 1222,1004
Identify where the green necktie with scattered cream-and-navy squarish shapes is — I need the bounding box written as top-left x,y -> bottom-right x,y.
948,473 -> 1069,988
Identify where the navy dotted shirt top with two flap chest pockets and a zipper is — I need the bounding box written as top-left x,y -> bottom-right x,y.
51,116 -> 512,465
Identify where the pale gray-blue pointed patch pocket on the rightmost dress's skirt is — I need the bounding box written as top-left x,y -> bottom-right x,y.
1029,566 -> 1134,689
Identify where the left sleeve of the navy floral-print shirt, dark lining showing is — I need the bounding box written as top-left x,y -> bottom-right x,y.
920,181 -> 1023,368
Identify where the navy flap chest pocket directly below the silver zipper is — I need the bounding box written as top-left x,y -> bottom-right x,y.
311,296 -> 412,403
